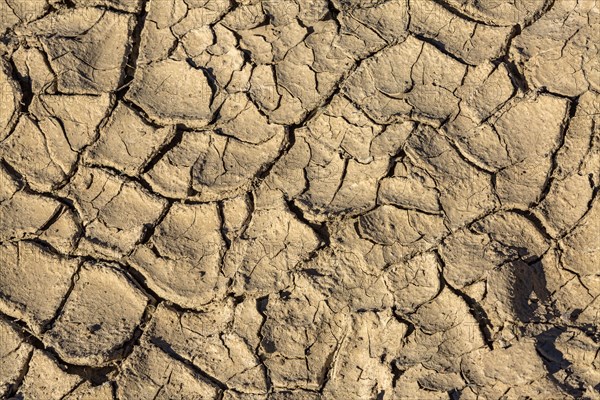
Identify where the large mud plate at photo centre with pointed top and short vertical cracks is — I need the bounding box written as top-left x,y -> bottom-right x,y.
269,96 -> 400,215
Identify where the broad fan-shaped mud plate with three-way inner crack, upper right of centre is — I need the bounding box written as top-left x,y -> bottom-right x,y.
343,36 -> 466,125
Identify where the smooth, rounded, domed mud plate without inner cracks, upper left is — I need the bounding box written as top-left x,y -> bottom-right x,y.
127,60 -> 213,128
